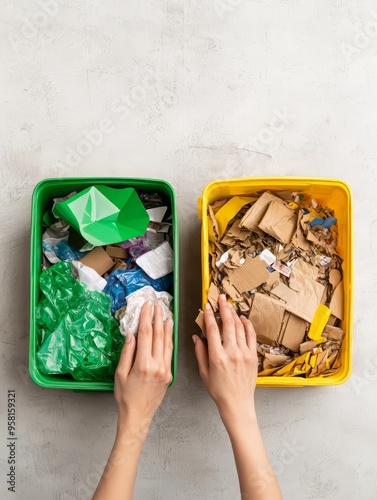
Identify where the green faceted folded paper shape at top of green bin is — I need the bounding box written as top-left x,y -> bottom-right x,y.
53,185 -> 149,246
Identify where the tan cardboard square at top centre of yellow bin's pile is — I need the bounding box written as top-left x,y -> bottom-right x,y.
258,200 -> 297,244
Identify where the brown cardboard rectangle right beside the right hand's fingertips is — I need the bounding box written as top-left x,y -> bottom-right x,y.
249,293 -> 285,345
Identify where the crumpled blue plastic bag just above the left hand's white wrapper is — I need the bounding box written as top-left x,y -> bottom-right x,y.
103,269 -> 173,314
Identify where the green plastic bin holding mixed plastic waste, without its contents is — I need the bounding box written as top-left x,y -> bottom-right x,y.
29,177 -> 179,391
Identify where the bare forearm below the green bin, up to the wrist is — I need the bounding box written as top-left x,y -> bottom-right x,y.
93,422 -> 149,500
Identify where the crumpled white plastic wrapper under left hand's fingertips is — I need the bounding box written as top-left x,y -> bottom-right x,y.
120,286 -> 173,335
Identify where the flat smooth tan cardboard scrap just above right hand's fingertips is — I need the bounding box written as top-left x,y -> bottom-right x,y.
229,257 -> 270,293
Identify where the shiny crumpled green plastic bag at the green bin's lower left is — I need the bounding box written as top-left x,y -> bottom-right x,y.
36,262 -> 124,381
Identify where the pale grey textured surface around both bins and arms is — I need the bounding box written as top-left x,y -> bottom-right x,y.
0,0 -> 377,500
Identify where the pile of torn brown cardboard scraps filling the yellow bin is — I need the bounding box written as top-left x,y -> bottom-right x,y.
197,191 -> 344,377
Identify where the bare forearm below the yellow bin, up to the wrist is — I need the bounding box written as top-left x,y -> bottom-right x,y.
222,415 -> 282,500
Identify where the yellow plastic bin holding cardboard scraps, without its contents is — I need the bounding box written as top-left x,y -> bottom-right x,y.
198,177 -> 353,387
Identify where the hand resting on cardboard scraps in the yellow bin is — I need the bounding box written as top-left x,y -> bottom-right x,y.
193,295 -> 258,428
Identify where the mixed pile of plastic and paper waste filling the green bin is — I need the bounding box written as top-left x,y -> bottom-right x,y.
36,185 -> 173,380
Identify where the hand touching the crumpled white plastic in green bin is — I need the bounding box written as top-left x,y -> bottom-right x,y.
114,301 -> 173,434
